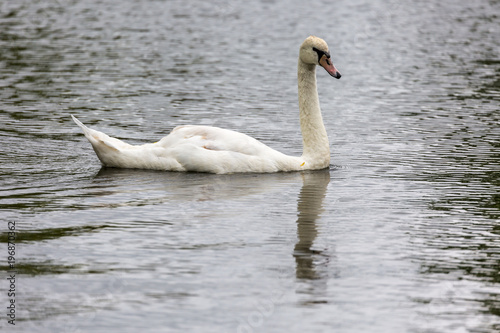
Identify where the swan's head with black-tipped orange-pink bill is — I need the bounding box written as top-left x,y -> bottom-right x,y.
299,36 -> 342,79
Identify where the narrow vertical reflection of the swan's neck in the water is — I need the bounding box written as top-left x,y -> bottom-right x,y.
293,170 -> 330,280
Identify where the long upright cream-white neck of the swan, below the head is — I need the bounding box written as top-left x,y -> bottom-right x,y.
298,58 -> 330,168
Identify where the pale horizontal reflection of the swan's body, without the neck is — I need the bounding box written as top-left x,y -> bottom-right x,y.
92,168 -> 308,205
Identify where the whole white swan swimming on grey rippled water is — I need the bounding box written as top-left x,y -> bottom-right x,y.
71,36 -> 341,174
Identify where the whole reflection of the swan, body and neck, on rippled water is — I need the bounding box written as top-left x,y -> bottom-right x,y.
92,168 -> 336,283
